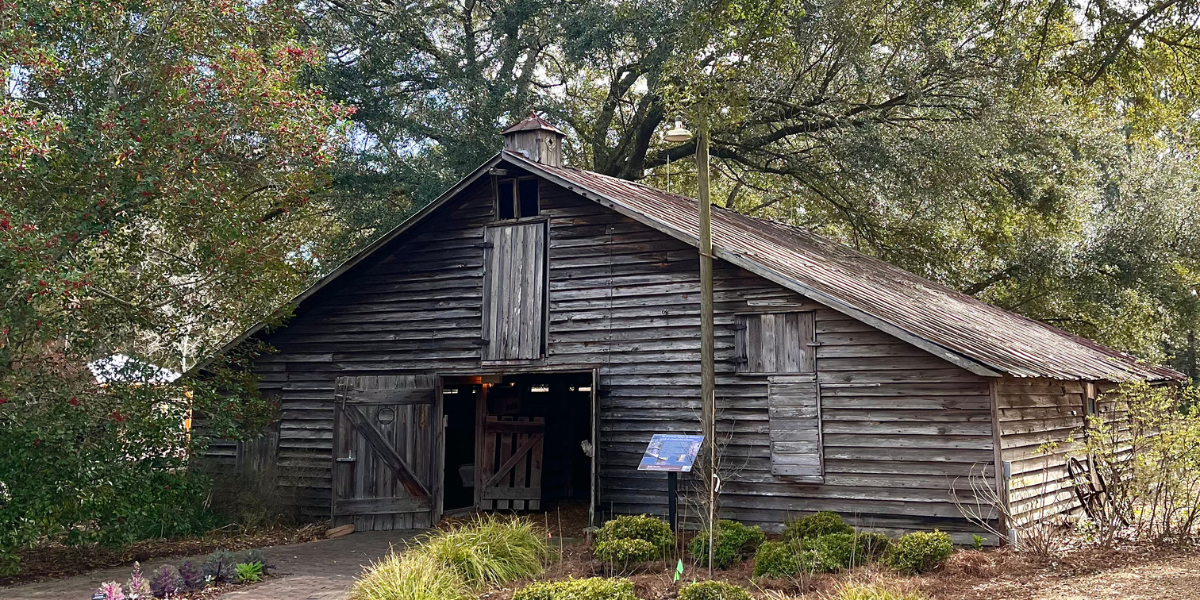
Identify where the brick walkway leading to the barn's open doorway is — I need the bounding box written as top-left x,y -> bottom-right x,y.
0,532 -> 415,600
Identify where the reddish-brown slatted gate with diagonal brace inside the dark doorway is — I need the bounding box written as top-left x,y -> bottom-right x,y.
478,416 -> 546,510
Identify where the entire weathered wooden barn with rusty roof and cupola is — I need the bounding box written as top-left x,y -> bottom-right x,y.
196,115 -> 1180,542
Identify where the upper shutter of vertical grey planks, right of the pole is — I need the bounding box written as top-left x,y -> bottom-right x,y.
734,312 -> 816,373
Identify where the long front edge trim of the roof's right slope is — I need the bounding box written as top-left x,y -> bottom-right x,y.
504,151 -> 1007,377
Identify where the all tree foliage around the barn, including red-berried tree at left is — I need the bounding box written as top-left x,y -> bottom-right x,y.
0,0 -> 1200,570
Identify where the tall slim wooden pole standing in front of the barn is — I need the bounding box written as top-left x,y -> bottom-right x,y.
696,101 -> 716,575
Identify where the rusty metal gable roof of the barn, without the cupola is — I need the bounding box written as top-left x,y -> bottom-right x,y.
193,151 -> 1183,382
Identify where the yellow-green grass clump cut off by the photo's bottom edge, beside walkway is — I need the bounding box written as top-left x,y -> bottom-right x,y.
350,552 -> 470,600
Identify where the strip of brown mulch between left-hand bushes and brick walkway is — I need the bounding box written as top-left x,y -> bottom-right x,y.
0,523 -> 328,586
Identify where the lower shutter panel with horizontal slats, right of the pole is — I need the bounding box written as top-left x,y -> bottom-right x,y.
767,374 -> 824,482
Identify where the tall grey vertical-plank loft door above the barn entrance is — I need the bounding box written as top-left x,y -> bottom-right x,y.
482,222 -> 546,361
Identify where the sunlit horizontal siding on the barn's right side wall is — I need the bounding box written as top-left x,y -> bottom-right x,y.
994,377 -> 1087,527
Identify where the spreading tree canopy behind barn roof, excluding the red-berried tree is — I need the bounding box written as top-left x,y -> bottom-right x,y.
306,0 -> 1200,374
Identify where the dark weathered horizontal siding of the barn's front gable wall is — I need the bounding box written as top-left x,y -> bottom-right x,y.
231,175 -> 994,541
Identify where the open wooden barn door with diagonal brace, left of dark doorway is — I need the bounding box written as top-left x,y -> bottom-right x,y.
332,376 -> 442,530
